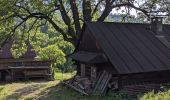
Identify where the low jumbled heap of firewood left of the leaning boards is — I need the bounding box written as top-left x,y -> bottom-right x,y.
66,76 -> 92,94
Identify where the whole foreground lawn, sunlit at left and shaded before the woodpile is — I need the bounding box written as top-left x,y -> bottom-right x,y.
0,80 -> 130,100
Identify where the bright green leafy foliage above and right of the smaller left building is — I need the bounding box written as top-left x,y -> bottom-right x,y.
7,23 -> 74,72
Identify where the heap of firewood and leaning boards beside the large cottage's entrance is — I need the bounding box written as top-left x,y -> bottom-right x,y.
63,71 -> 112,95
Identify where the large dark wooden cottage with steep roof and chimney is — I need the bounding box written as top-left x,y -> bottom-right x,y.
68,17 -> 170,97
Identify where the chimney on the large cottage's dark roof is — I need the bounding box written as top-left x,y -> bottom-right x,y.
151,17 -> 163,35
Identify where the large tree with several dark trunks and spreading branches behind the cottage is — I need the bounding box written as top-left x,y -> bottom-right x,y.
0,0 -> 170,45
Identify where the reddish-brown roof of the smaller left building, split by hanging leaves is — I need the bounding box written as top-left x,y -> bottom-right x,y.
0,41 -> 36,59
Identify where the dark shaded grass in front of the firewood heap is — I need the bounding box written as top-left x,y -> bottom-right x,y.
36,83 -> 113,100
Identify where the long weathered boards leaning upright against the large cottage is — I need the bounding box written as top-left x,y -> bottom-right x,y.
93,71 -> 112,95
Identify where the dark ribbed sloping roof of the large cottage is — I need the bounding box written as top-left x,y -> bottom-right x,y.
86,22 -> 170,74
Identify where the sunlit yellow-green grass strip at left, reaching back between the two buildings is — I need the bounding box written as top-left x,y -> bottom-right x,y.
0,72 -> 75,100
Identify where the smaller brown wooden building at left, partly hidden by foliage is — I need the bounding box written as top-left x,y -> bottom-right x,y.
0,41 -> 51,81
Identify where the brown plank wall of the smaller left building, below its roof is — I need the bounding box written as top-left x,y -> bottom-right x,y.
0,59 -> 52,80
